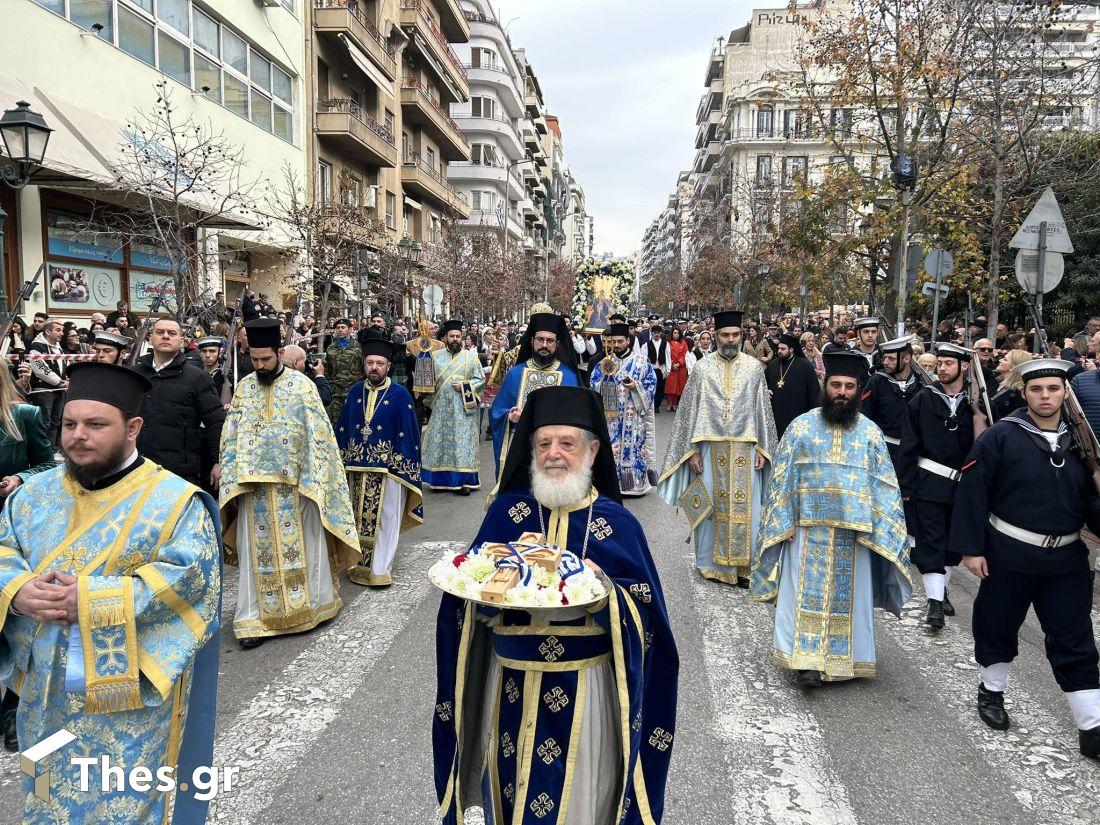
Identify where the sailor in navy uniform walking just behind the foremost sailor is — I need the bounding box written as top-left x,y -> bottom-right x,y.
897,343 -> 974,629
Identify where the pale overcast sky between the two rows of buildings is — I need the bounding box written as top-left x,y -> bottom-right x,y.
495,0 -> 756,255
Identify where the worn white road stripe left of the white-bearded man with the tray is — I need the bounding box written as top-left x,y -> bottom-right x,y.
209,542 -> 458,825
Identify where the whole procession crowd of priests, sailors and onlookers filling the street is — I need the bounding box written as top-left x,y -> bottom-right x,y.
0,292 -> 1100,824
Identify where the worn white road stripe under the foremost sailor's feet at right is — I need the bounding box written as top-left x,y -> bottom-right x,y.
876,589 -> 1100,825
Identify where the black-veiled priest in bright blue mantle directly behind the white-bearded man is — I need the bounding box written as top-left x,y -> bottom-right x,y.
490,312 -> 581,479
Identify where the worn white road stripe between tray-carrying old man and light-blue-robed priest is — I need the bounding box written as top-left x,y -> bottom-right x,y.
691,572 -> 857,825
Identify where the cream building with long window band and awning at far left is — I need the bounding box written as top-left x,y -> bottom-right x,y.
0,0 -> 312,321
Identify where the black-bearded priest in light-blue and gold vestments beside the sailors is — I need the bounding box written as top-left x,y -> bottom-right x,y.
750,352 -> 913,688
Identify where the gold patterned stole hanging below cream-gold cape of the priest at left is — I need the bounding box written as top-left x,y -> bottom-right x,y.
244,484 -> 314,630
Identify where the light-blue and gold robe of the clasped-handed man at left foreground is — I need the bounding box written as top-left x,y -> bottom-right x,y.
0,460 -> 221,825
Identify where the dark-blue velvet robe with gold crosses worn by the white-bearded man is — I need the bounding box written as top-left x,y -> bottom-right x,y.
432,491 -> 679,825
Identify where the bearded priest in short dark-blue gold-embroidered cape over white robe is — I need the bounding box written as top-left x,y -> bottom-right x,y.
337,328 -> 424,587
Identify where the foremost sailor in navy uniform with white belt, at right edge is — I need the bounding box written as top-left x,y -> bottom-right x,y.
948,359 -> 1100,759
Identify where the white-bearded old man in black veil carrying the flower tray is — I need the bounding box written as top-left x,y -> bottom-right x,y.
432,387 -> 679,825
